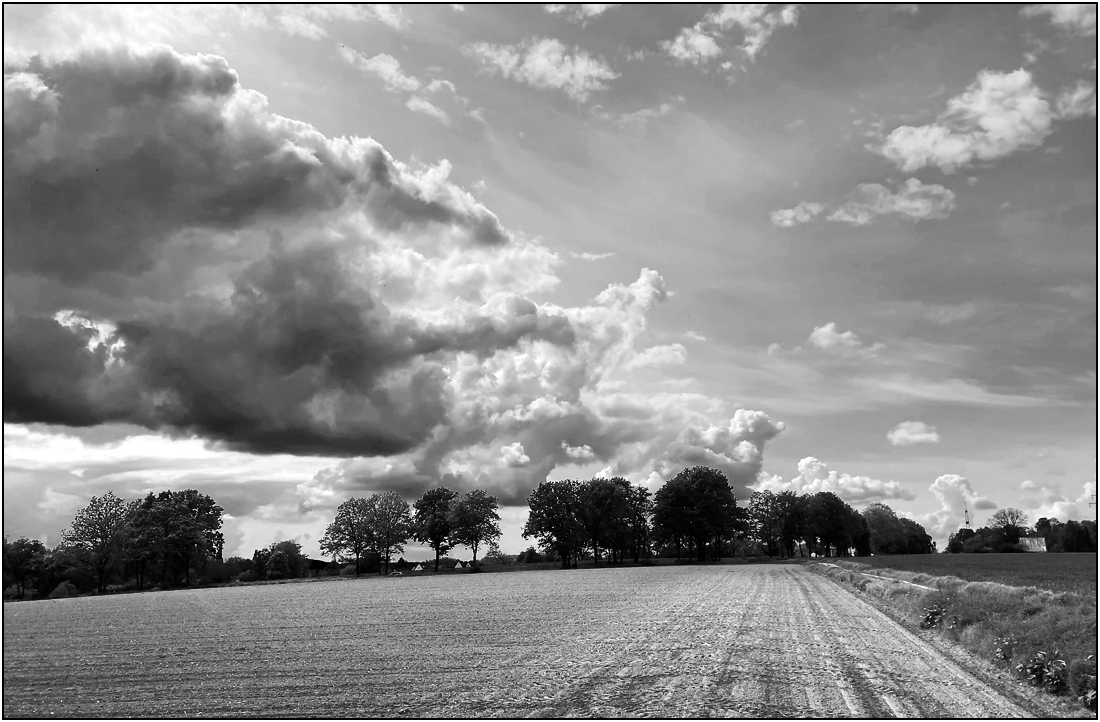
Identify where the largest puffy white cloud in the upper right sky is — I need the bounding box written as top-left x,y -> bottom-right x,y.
878,69 -> 1054,173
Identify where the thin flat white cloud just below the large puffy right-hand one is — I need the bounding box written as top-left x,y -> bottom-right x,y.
771,178 -> 955,228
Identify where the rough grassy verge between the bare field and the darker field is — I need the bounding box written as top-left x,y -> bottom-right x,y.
810,561 -> 1097,711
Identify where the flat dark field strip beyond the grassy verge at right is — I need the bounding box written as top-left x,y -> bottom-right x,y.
853,554 -> 1097,597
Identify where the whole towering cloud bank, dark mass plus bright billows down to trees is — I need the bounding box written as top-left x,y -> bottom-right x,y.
3,46 -> 784,524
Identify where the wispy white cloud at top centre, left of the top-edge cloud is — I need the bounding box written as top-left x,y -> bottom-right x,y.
462,39 -> 619,102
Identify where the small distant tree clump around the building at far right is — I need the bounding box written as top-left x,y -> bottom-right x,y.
946,506 -> 1097,554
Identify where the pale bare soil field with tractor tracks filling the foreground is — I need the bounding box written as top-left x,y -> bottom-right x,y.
3,565 -> 1056,718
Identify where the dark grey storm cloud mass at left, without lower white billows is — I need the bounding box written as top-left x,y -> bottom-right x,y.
3,47 -> 573,456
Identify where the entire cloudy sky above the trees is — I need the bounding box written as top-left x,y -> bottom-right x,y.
3,4 -> 1097,559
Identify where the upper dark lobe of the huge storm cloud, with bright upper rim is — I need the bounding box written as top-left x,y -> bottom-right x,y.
3,47 -> 508,281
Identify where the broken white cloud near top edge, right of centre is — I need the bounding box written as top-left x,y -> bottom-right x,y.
660,3 -> 799,69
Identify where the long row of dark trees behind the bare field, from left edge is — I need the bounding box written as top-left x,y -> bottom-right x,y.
3,467 -> 946,595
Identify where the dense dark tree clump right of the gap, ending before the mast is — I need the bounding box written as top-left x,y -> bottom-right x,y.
523,467 -> 935,568
